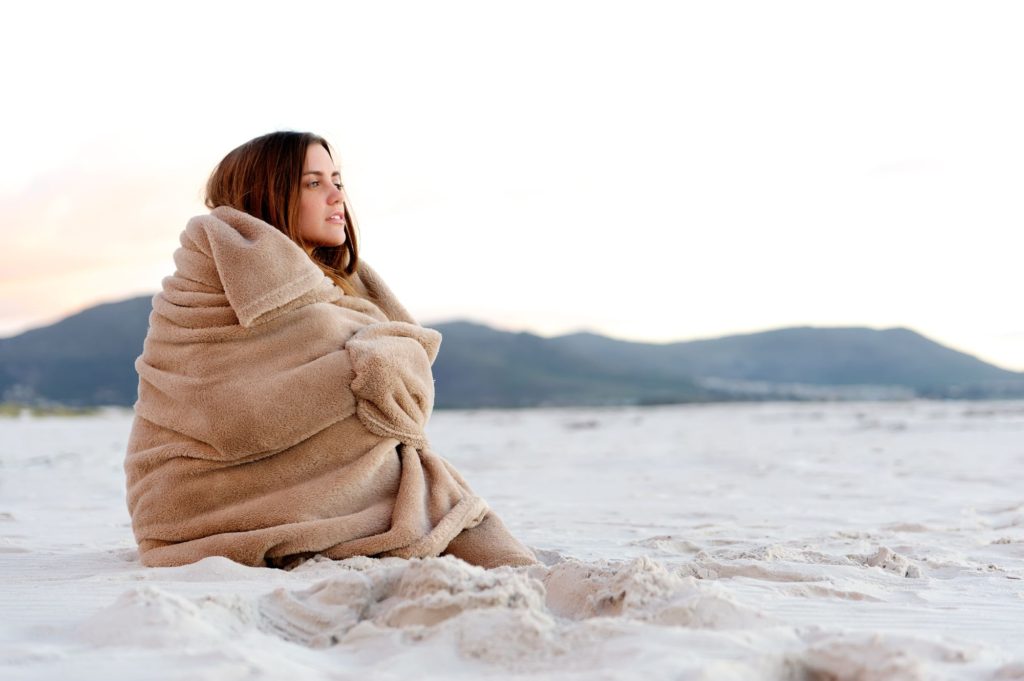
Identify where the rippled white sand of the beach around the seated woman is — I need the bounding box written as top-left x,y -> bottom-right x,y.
0,402 -> 1024,681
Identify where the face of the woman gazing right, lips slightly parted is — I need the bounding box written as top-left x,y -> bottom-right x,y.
298,143 -> 345,246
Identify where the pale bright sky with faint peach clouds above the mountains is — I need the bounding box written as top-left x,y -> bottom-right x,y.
0,0 -> 1024,371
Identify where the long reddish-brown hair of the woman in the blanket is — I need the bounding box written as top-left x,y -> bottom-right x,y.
206,131 -> 359,295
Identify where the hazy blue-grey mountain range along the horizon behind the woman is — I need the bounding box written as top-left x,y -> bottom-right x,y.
0,296 -> 1024,408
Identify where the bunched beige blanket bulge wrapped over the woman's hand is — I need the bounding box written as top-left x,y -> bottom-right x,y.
345,322 -> 441,446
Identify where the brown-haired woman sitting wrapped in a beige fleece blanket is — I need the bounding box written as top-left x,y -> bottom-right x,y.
125,132 -> 536,567
